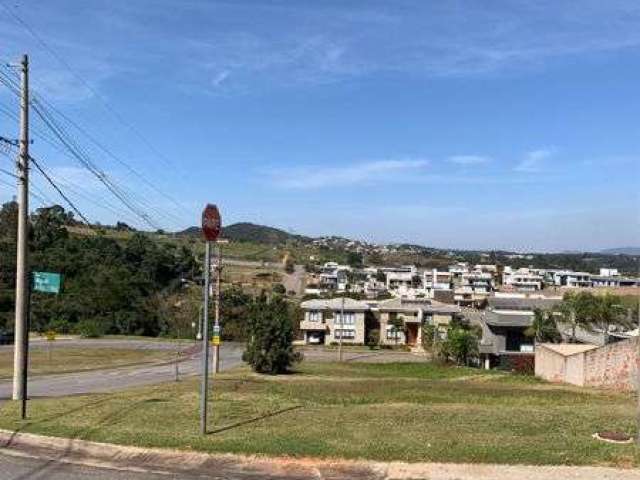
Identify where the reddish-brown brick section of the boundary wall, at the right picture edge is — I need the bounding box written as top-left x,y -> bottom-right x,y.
584,338 -> 640,391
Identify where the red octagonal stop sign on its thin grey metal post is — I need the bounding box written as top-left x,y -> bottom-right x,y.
200,204 -> 221,435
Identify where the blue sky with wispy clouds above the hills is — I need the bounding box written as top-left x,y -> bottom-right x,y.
0,0 -> 640,251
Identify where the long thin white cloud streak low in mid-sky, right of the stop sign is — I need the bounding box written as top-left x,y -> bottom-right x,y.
271,159 -> 429,190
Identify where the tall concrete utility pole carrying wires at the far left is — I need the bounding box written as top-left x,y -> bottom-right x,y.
13,55 -> 29,400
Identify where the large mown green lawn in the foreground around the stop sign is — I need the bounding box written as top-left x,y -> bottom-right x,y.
0,363 -> 640,467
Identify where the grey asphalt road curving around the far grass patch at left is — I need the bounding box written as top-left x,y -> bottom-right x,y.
0,340 -> 243,400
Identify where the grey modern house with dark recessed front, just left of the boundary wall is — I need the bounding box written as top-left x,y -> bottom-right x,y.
479,294 -> 562,368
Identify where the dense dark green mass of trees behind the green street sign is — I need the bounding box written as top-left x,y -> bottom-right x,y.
0,202 -> 198,335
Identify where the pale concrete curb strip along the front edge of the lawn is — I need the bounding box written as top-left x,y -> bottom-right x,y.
0,430 -> 640,480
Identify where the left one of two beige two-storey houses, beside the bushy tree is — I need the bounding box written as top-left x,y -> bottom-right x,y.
300,297 -> 371,345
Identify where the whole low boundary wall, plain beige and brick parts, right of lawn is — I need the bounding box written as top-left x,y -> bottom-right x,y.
535,337 -> 640,391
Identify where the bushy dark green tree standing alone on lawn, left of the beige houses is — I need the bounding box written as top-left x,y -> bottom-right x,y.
242,294 -> 302,375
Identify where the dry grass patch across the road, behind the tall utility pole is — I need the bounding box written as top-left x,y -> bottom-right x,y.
0,346 -> 175,379
